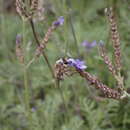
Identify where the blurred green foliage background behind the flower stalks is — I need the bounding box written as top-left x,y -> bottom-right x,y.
0,0 -> 130,130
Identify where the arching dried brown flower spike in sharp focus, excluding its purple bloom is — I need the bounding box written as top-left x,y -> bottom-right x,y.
56,59 -> 121,99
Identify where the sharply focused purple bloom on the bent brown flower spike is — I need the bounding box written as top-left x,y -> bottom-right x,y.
67,58 -> 87,70
